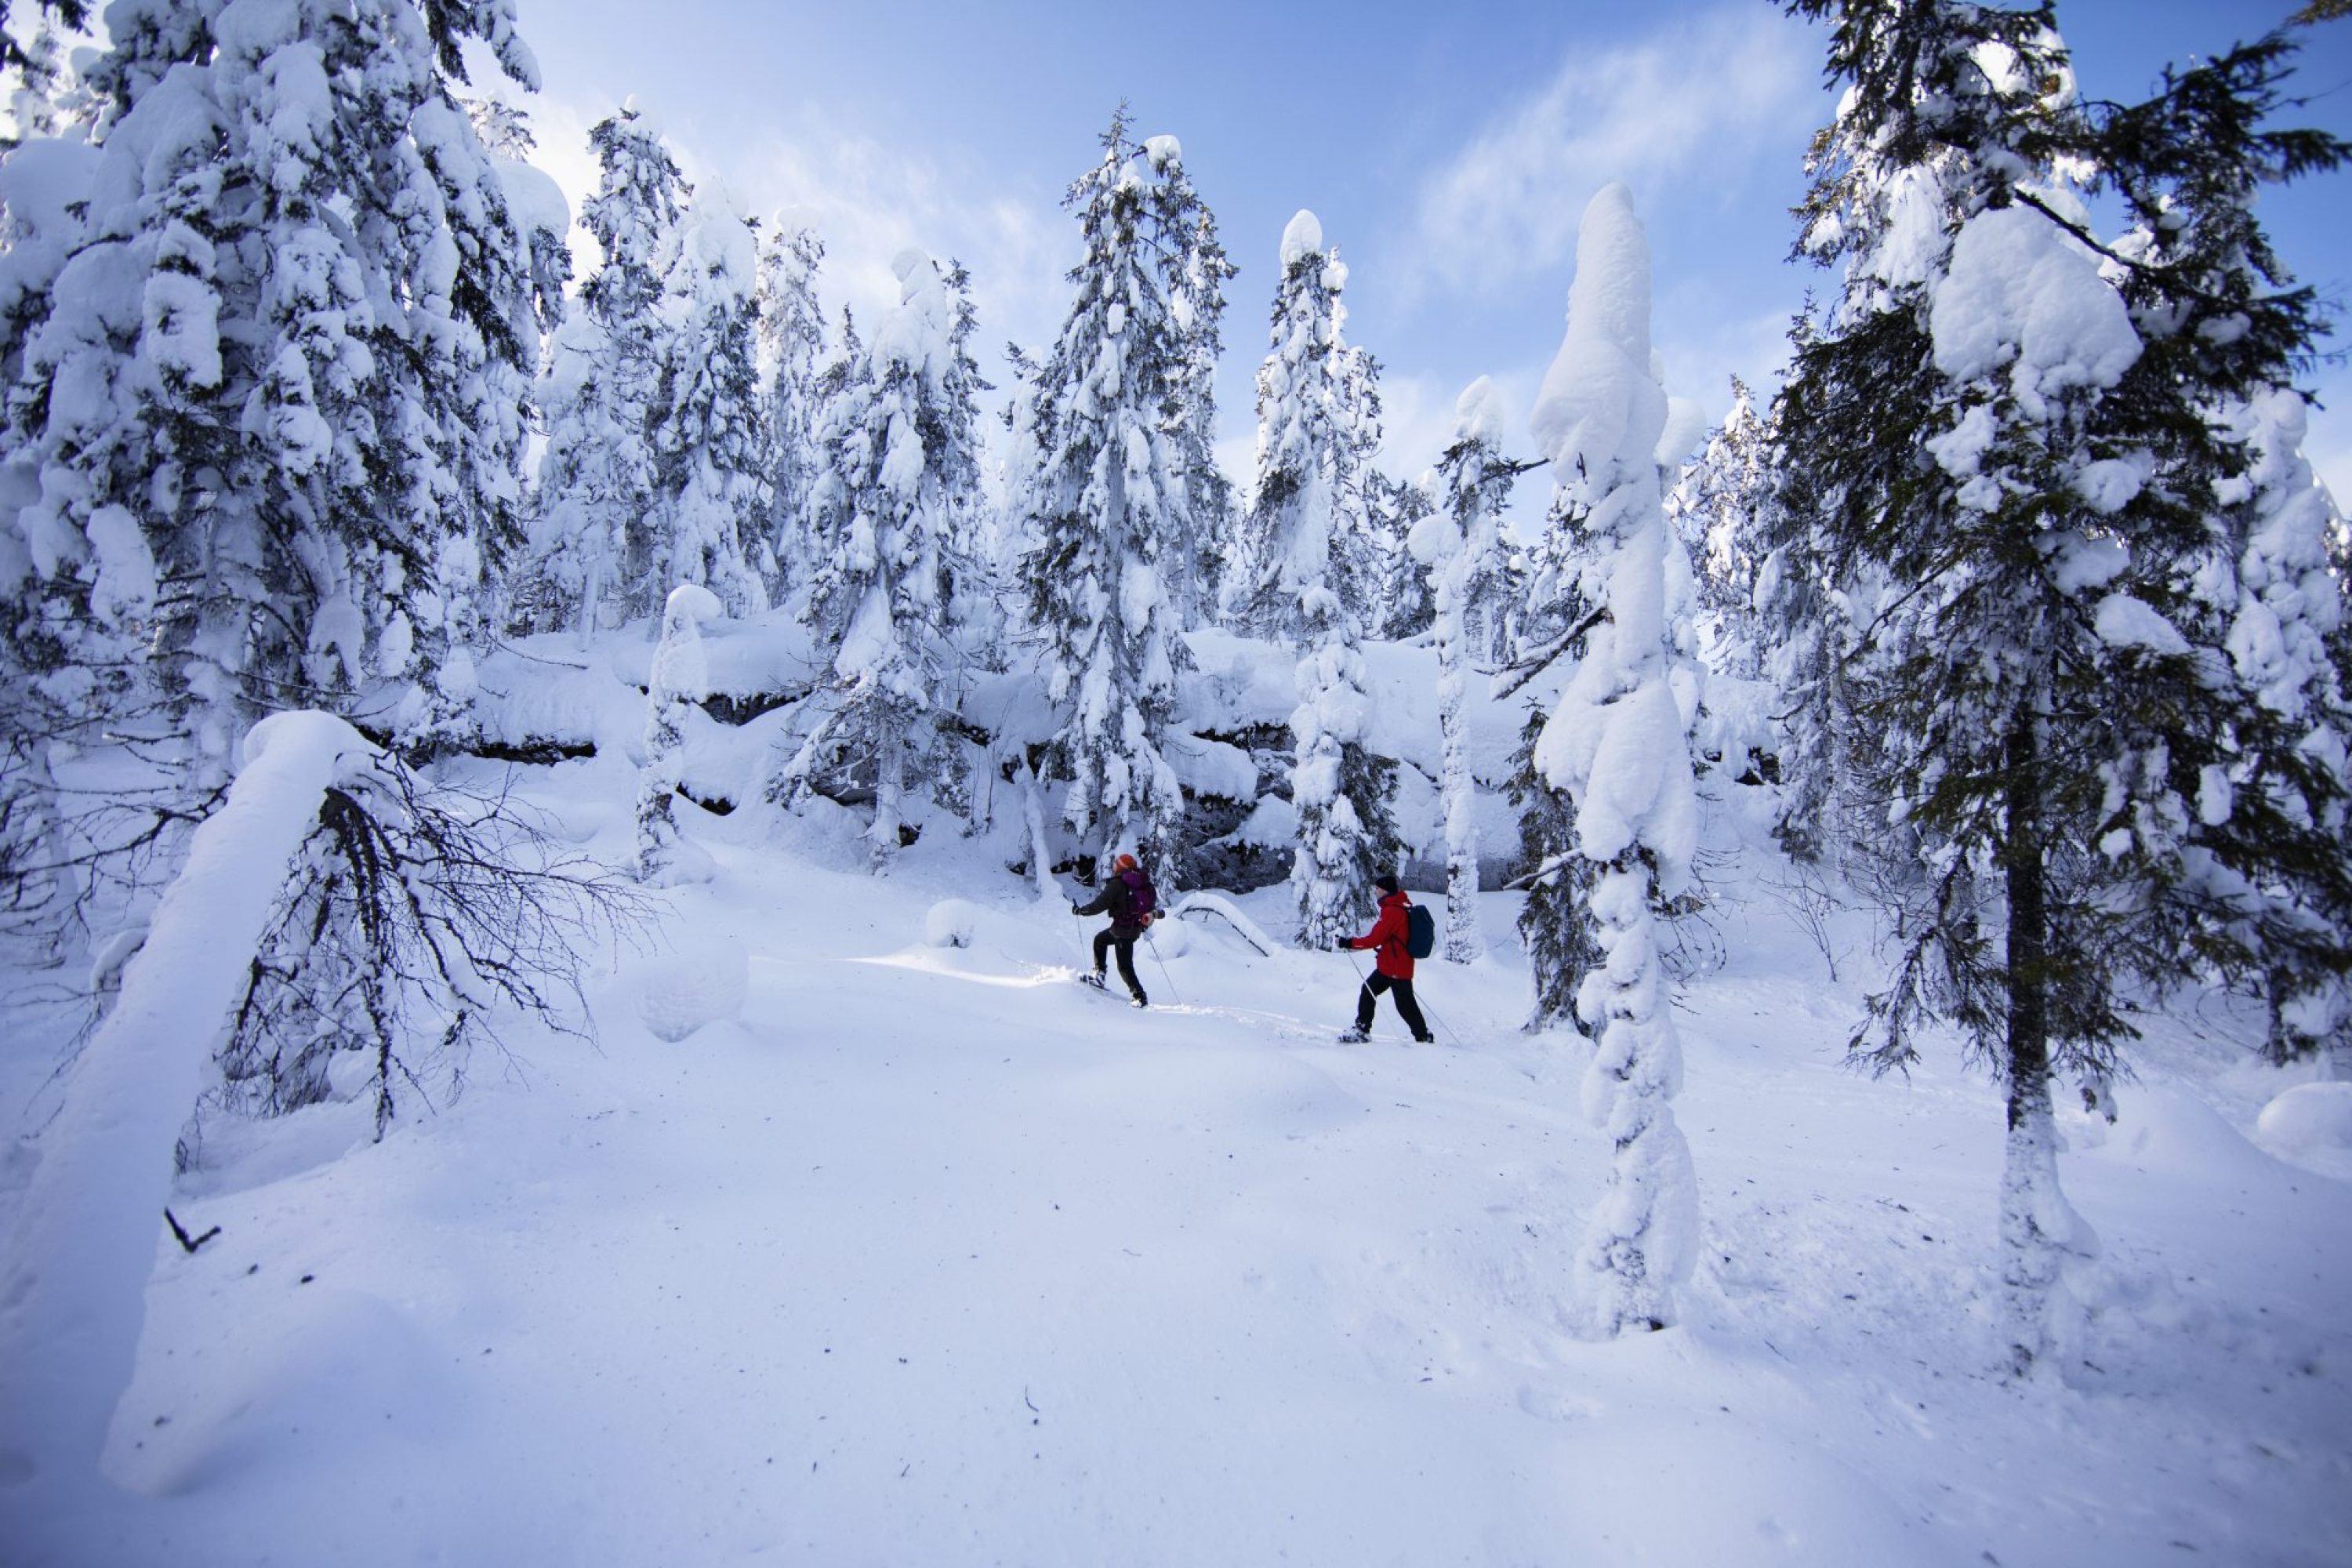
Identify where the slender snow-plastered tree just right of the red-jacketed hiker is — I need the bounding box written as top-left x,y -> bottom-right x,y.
1414,376 -> 1519,964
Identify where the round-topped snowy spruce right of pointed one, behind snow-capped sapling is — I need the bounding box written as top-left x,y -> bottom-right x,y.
644,188 -> 776,616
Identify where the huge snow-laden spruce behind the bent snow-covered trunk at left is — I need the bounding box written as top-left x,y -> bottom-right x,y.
7,0 -> 536,787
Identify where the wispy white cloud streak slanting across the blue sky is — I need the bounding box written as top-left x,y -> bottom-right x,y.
1406,5 -> 1820,292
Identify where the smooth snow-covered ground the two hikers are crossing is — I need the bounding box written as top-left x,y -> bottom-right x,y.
0,760 -> 2352,1568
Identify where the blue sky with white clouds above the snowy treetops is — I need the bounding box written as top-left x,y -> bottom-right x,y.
517,0 -> 2352,496
